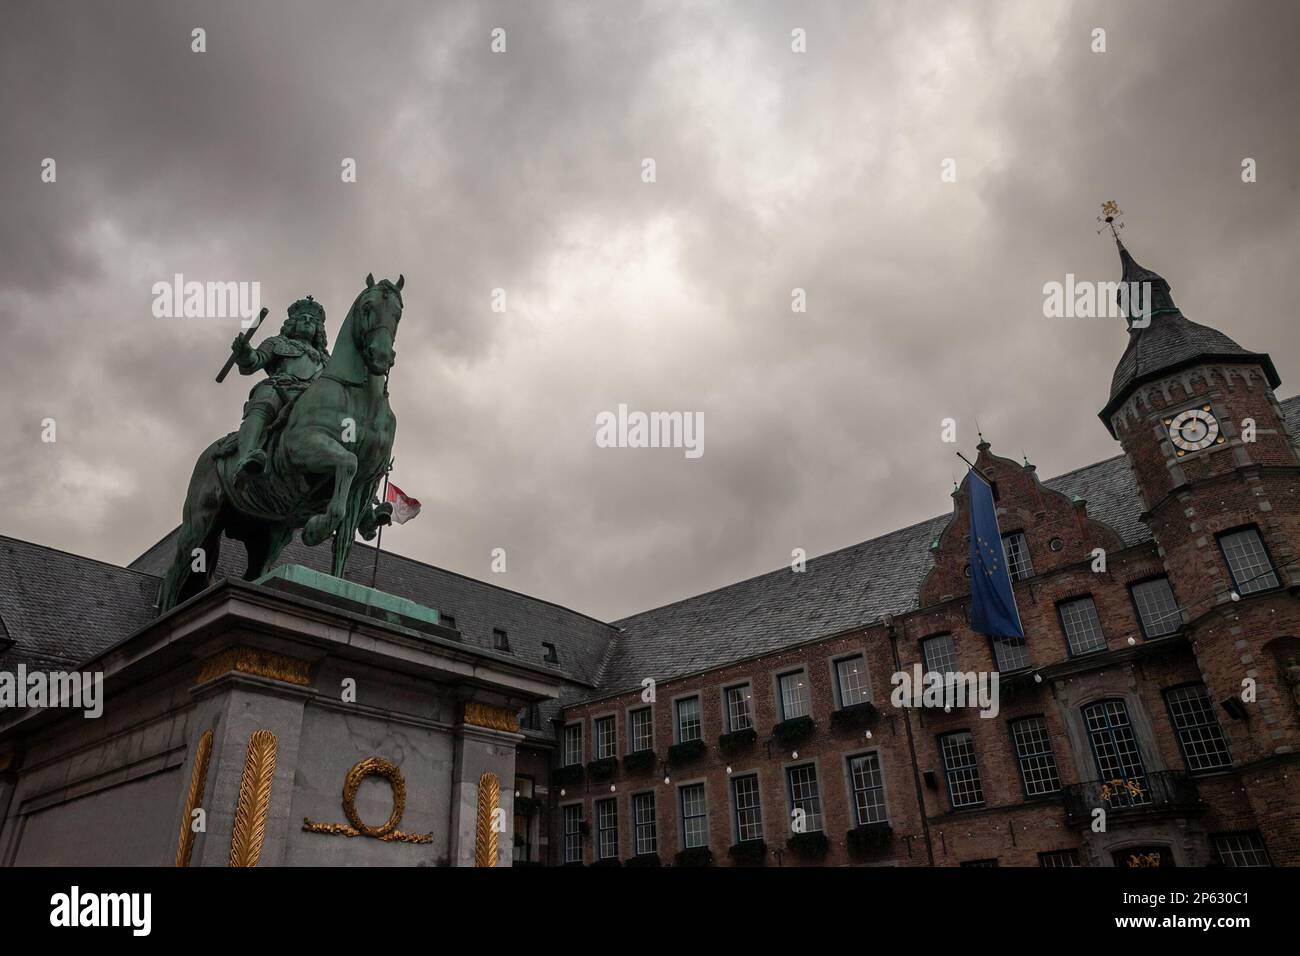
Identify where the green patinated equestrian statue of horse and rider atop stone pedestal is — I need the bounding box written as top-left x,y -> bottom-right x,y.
161,276 -> 406,610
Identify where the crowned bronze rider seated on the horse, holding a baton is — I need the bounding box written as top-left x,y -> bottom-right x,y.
230,295 -> 329,475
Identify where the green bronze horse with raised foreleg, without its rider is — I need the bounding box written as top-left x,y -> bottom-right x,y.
161,276 -> 406,611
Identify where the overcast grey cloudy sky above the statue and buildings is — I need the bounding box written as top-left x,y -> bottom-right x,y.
0,0 -> 1300,618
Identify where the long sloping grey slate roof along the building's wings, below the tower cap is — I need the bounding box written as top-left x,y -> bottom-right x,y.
0,395 -> 1300,736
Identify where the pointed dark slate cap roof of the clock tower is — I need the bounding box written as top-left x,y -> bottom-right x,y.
1101,243 -> 1281,428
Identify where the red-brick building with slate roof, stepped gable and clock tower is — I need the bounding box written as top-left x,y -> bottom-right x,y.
547,245 -> 1300,866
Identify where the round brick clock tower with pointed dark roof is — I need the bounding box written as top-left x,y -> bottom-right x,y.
1100,227 -> 1300,865
